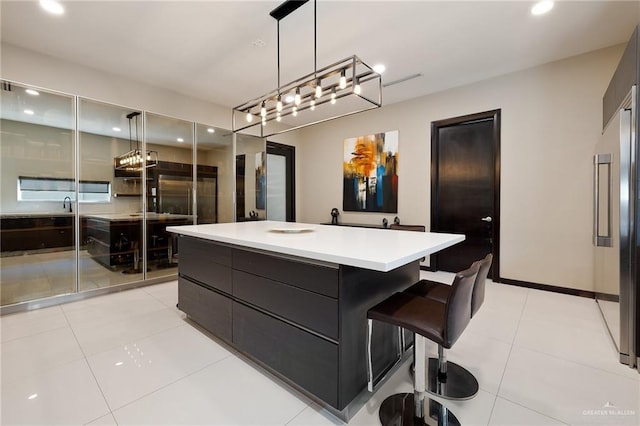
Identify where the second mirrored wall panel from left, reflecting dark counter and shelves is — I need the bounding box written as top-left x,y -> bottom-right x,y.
78,99 -> 144,291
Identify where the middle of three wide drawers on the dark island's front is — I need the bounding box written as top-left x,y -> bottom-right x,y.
233,270 -> 338,340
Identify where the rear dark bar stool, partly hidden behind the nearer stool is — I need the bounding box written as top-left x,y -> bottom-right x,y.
404,253 -> 493,400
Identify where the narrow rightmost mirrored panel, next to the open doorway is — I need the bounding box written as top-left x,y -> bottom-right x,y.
236,133 -> 267,222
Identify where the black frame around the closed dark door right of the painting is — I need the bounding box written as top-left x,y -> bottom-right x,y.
430,109 -> 501,282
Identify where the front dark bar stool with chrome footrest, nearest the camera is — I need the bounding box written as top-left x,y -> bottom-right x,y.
367,264 -> 479,426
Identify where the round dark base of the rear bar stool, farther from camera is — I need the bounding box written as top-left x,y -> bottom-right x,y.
409,358 -> 480,400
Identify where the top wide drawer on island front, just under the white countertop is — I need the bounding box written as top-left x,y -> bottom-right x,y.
231,249 -> 339,299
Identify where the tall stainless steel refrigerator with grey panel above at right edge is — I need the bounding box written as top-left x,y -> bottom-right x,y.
593,28 -> 640,368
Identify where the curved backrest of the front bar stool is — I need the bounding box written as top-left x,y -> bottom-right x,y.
442,262 -> 480,349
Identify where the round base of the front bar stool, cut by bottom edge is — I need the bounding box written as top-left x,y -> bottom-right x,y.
380,393 -> 460,426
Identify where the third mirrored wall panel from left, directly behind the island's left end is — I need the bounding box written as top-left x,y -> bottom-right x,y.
145,113 -> 195,278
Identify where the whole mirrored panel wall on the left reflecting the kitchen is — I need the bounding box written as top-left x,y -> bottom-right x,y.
0,81 -> 266,308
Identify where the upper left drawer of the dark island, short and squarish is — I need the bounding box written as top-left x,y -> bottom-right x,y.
178,237 -> 232,294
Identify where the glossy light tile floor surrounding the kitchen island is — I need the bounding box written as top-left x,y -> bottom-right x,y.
0,273 -> 640,426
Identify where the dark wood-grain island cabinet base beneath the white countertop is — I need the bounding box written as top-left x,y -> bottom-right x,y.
178,235 -> 419,412
